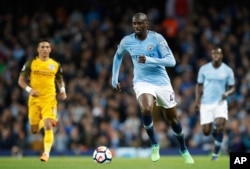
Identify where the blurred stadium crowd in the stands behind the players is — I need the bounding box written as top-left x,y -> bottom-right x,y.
0,0 -> 250,154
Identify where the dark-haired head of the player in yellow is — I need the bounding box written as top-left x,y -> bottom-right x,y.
37,39 -> 51,57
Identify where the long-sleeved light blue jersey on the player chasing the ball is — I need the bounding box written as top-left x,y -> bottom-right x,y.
112,31 -> 176,87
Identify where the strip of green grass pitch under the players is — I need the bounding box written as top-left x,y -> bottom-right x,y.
0,156 -> 229,169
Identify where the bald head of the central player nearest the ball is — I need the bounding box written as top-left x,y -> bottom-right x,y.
132,13 -> 148,37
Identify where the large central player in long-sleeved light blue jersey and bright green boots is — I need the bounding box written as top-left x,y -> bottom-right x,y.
112,13 -> 194,163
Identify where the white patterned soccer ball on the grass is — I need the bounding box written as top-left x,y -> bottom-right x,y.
93,146 -> 112,163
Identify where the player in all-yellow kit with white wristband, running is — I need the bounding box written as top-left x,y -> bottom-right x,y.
18,39 -> 67,162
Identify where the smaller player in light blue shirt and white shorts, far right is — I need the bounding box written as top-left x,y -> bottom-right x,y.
196,48 -> 235,160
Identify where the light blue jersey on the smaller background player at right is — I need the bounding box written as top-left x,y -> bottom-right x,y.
197,62 -> 235,104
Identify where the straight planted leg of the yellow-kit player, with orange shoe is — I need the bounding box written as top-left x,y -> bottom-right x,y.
40,103 -> 57,162
